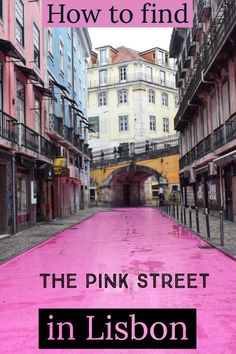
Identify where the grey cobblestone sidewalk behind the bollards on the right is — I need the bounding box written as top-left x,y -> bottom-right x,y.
162,208 -> 236,260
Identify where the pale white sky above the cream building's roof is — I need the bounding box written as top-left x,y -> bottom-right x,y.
89,27 -> 172,52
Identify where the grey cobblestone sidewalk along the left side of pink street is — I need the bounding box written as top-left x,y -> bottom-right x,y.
0,207 -> 108,264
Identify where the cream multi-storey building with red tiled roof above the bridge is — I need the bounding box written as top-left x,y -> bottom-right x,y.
88,46 -> 178,150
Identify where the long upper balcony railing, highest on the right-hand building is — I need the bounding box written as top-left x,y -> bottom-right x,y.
175,0 -> 236,127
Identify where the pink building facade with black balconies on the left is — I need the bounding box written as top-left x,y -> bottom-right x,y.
0,0 -> 91,238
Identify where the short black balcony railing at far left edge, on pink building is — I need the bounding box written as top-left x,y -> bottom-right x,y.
0,110 -> 17,143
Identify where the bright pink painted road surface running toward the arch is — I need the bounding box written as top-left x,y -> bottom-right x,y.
0,208 -> 236,354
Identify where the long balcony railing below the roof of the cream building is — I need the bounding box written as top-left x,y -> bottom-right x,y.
88,73 -> 175,89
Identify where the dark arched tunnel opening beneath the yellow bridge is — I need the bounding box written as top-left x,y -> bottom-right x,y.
101,163 -> 166,206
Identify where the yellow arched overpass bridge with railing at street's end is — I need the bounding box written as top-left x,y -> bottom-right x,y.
90,135 -> 179,206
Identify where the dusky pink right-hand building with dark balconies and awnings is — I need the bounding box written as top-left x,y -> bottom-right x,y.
170,0 -> 236,221
